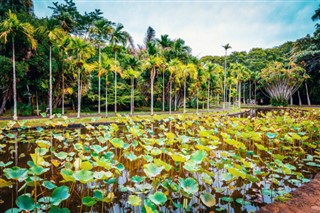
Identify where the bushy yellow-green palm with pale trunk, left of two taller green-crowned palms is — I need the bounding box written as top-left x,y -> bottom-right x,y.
70,37 -> 94,118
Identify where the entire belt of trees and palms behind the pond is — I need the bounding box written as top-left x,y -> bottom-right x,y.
0,0 -> 320,117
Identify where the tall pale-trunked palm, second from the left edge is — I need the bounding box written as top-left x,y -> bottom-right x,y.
37,19 -> 65,119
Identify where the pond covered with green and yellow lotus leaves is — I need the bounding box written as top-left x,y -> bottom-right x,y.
0,109 -> 320,213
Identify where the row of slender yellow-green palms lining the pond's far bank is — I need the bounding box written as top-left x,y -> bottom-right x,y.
0,10 -> 254,120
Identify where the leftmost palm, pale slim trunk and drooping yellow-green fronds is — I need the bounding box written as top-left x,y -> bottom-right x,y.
0,10 -> 37,121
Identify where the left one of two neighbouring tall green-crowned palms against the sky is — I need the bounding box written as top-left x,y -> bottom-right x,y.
90,19 -> 112,114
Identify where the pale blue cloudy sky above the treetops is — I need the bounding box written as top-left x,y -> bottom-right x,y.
33,0 -> 320,57
